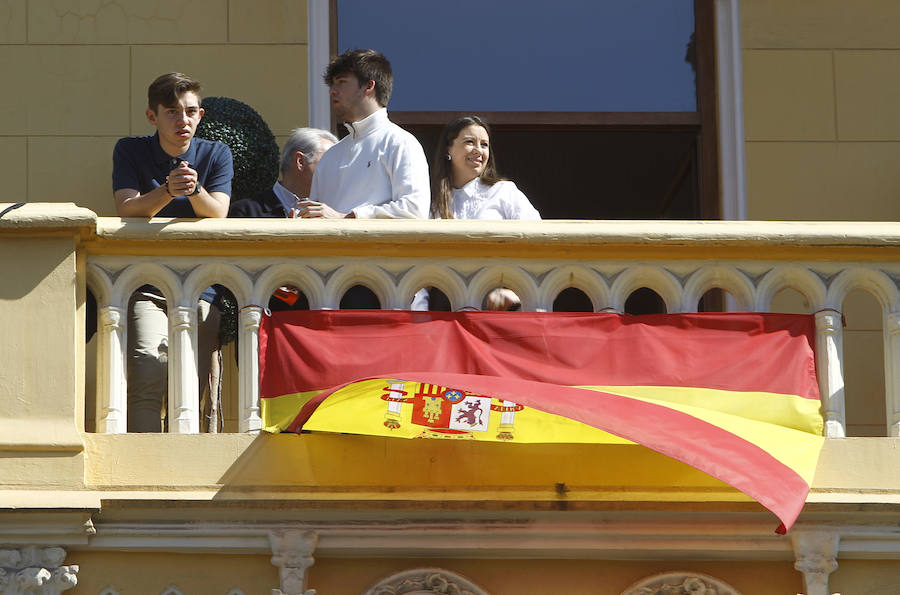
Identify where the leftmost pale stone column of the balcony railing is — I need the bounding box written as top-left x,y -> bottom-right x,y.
97,306 -> 128,434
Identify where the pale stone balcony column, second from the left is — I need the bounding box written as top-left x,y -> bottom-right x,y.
168,306 -> 200,434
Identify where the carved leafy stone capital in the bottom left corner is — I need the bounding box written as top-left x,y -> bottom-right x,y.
0,545 -> 78,595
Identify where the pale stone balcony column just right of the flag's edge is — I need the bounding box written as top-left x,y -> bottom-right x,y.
816,310 -> 847,438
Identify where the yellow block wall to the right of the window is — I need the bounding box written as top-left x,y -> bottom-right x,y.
741,0 -> 900,221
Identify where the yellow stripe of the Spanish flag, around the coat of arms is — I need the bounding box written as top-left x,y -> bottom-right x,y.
262,379 -> 823,483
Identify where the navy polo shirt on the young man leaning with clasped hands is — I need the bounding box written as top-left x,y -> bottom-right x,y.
113,134 -> 234,217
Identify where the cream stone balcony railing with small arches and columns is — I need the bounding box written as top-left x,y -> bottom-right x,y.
79,218 -> 900,437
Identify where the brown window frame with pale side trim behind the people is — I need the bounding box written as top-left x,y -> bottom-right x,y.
307,0 -> 746,220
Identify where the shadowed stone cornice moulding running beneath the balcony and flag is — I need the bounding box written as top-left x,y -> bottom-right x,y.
75,514 -> 900,560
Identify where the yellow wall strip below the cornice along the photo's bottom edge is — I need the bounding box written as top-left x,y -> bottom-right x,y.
67,550 -> 804,595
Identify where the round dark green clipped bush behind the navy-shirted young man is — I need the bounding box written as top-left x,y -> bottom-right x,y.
197,97 -> 280,202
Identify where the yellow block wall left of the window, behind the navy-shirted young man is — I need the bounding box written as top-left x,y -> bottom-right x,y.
0,0 -> 308,215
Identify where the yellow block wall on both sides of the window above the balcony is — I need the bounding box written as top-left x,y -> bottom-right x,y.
7,0 -> 900,220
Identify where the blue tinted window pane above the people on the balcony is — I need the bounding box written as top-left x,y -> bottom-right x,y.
337,0 -> 697,112
